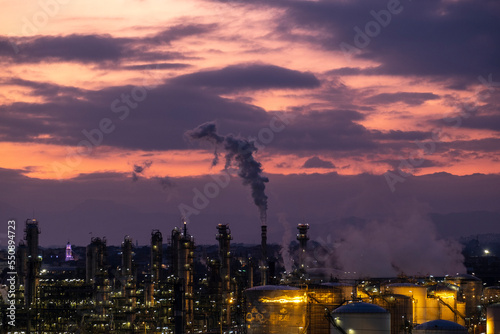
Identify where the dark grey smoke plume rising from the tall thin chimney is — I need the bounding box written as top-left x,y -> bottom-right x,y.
185,122 -> 269,224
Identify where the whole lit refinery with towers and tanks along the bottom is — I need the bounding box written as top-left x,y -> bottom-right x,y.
0,219 -> 500,334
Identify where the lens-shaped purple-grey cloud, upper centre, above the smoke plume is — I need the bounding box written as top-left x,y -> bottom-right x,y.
172,64 -> 320,91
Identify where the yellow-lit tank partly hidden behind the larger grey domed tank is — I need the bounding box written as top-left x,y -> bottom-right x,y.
385,283 -> 427,324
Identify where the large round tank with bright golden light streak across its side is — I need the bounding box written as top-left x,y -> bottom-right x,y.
245,285 -> 307,334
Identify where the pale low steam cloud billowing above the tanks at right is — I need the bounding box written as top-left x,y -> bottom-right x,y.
335,214 -> 465,277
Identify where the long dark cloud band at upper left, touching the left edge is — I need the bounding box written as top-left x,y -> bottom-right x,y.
0,24 -> 217,64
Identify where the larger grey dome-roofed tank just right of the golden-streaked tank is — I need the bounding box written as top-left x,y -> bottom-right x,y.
330,303 -> 391,334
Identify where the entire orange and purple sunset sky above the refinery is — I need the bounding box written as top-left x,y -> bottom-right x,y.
0,0 -> 500,271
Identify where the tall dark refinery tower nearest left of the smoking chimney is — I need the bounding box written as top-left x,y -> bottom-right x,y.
216,224 -> 233,327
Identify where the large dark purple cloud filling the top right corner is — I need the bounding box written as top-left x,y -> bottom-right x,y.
245,0 -> 500,85
